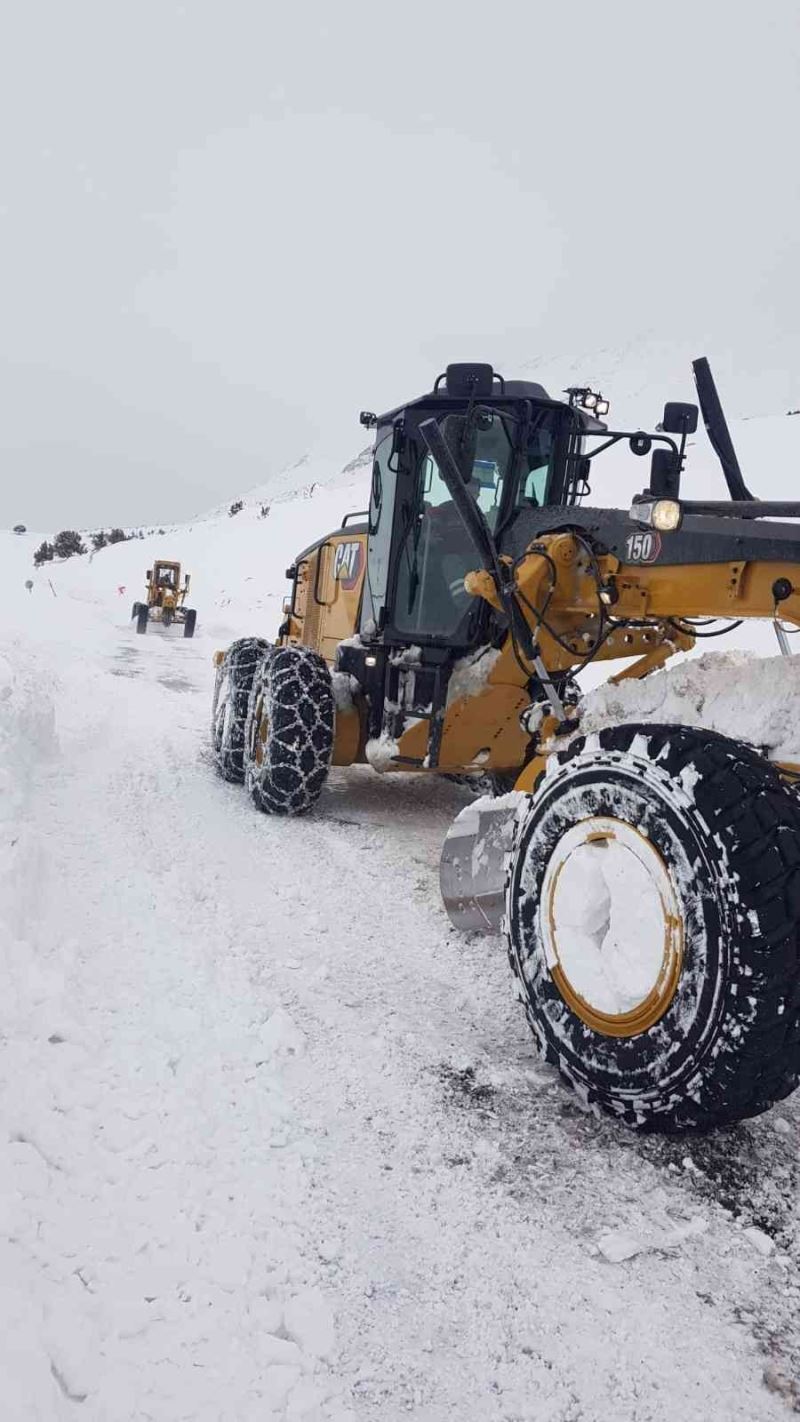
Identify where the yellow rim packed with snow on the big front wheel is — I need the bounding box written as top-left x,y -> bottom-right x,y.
539,816 -> 683,1037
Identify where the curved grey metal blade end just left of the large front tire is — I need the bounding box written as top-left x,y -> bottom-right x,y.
439,791 -> 529,933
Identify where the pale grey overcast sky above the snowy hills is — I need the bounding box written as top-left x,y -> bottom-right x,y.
0,0 -> 800,530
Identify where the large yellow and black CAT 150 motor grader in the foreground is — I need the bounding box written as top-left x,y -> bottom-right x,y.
213,358 -> 800,1132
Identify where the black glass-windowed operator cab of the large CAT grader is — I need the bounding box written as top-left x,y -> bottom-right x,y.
360,365 -> 604,650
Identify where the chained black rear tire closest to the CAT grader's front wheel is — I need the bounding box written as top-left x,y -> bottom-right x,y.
244,647 -> 334,815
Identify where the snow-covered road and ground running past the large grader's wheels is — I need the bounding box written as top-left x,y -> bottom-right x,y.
0,560 -> 799,1422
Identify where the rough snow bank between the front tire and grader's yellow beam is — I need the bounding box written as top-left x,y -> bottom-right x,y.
581,651 -> 800,762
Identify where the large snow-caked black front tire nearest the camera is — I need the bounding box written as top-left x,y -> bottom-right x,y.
506,725 -> 800,1132
